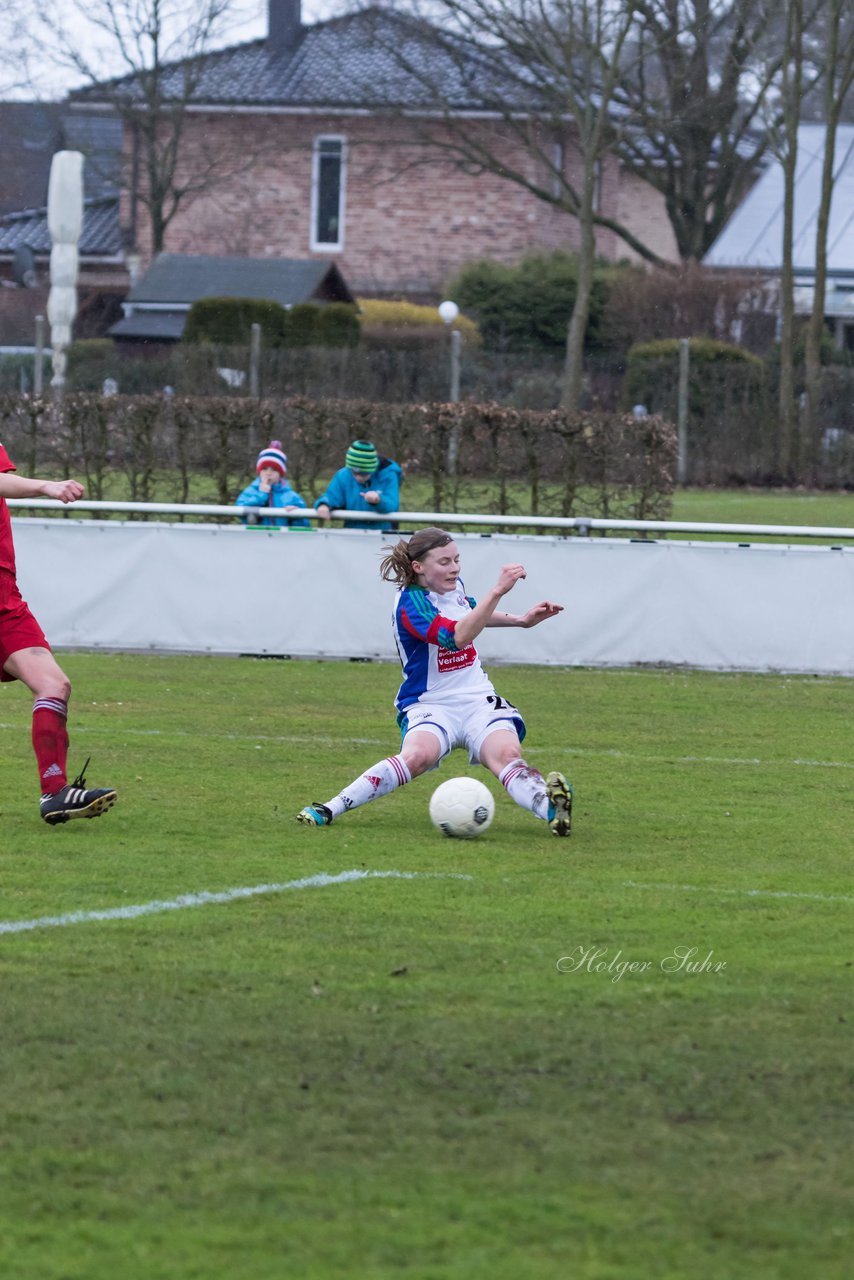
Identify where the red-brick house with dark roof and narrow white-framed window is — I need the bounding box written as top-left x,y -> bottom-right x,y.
72,0 -> 677,300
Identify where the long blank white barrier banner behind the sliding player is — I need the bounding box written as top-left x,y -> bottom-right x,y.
13,518 -> 854,676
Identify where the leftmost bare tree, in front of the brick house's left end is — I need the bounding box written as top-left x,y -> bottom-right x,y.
33,0 -> 248,253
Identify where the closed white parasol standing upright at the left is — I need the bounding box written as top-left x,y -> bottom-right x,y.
47,151 -> 83,402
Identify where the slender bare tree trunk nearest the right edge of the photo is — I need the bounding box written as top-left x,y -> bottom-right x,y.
802,0 -> 854,465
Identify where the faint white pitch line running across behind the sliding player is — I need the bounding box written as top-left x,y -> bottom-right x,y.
0,721 -> 854,769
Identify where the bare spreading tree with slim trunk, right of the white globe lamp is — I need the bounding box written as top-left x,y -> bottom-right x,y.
363,0 -> 658,407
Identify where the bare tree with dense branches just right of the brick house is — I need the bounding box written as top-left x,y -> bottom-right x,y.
618,0 -> 782,261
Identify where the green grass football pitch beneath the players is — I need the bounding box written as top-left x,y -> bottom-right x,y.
0,645 -> 854,1280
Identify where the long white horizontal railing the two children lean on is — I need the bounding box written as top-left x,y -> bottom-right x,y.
6,498 -> 854,540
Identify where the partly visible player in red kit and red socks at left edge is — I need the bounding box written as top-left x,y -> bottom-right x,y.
0,444 -> 115,826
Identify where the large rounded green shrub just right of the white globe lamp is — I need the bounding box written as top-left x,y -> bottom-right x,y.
448,251 -> 608,351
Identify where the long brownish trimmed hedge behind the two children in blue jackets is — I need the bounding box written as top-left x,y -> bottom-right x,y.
0,394 -> 676,520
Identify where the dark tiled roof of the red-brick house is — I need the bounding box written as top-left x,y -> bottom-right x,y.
66,9 -> 517,110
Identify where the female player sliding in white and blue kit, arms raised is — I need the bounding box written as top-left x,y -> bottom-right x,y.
297,529 -> 572,836
